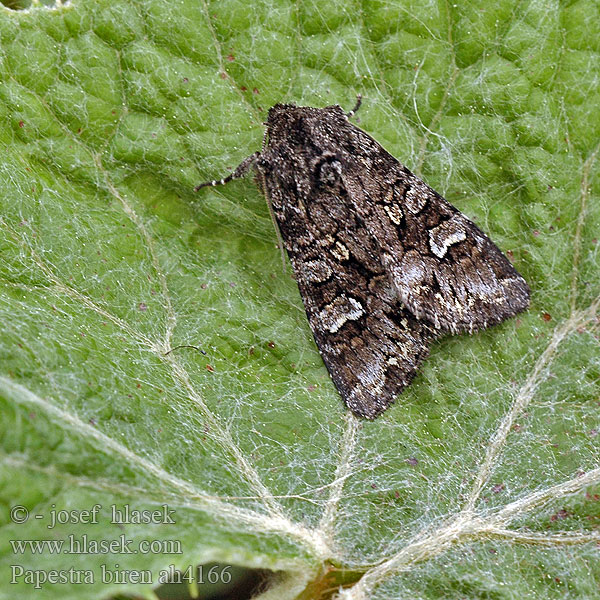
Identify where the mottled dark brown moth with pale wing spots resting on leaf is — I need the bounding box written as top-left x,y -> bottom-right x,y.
195,96 -> 529,419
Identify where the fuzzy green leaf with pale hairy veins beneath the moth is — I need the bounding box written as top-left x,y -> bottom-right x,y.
0,0 -> 600,600
